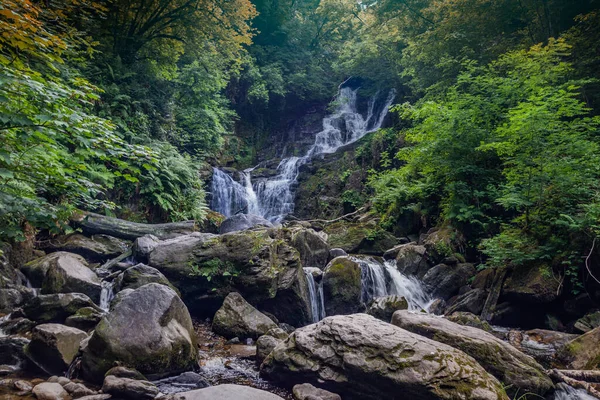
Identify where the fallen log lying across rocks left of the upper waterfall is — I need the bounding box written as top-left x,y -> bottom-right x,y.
71,212 -> 196,240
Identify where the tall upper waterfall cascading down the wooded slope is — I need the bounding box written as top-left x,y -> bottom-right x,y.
211,87 -> 396,222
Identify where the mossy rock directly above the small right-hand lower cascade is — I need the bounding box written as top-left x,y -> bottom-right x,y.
325,221 -> 398,255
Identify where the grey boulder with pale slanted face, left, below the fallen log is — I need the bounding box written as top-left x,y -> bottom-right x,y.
42,251 -> 102,303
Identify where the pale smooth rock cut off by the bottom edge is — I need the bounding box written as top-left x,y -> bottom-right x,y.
167,384 -> 283,400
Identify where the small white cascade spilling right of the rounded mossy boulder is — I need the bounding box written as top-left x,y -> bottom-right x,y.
353,257 -> 432,311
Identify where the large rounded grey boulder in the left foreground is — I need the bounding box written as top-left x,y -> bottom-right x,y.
82,283 -> 197,382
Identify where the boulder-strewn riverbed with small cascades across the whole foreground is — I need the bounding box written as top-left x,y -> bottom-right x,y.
0,216 -> 600,400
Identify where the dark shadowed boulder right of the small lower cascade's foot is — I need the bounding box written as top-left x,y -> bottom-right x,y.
423,263 -> 476,300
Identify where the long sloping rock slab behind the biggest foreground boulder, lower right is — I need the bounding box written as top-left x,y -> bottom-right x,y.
392,311 -> 553,395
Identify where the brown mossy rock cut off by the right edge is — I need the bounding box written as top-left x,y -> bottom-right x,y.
556,328 -> 600,369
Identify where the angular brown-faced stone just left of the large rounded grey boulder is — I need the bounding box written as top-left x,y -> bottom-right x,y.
25,324 -> 87,374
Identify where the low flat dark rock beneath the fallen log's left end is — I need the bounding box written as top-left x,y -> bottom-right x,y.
42,233 -> 130,262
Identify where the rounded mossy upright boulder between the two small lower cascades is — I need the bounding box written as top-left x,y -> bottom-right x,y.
323,256 -> 362,315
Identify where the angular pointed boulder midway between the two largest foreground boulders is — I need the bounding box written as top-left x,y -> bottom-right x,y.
212,292 -> 277,340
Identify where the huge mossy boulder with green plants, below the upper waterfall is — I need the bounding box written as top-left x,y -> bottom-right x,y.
148,229 -> 311,326
